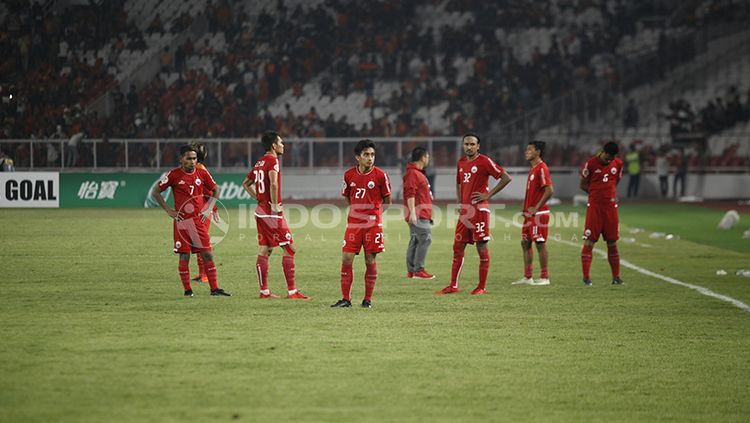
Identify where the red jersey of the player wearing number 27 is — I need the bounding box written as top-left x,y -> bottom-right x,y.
341,166 -> 391,224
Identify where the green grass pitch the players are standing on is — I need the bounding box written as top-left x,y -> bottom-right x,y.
0,204 -> 750,422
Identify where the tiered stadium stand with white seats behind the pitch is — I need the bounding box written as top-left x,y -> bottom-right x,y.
0,0 -> 750,173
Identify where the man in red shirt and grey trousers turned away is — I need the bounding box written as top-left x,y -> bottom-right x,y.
403,147 -> 435,279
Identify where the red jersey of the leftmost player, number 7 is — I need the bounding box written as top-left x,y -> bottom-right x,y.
159,167 -> 216,219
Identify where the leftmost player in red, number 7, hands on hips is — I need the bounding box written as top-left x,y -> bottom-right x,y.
151,145 -> 231,297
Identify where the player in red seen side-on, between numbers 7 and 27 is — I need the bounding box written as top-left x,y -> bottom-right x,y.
242,131 -> 308,300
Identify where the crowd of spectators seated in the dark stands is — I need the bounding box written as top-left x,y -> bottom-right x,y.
0,0 -> 747,169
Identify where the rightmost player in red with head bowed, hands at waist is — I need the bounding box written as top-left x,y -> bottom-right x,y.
580,142 -> 623,286
